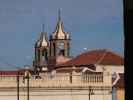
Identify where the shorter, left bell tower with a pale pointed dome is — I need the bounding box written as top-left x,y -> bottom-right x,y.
33,24 -> 49,72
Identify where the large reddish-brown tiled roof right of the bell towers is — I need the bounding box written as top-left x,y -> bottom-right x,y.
59,49 -> 124,66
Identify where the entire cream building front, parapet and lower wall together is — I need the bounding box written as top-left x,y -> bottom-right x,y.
0,72 -> 112,100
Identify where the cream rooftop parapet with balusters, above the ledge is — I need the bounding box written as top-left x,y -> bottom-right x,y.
0,73 -> 111,87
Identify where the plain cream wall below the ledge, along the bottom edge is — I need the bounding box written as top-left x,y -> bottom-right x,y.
0,90 -> 112,100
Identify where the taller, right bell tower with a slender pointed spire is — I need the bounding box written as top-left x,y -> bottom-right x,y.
50,10 -> 70,58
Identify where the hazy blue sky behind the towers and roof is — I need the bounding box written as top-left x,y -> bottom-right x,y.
0,0 -> 124,70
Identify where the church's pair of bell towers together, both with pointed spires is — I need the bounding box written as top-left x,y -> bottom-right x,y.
33,11 -> 71,72
